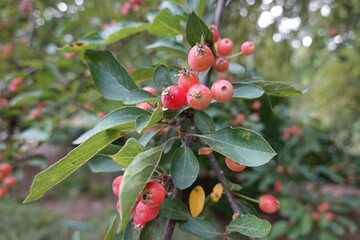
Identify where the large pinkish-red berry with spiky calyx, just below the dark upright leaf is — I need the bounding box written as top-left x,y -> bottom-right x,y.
188,45 -> 214,72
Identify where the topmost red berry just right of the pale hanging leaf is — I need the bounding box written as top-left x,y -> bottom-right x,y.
141,182 -> 166,208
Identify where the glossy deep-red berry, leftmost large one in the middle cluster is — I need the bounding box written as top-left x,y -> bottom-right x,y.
161,86 -> 186,110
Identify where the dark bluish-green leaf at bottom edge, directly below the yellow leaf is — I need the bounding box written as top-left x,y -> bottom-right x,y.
179,218 -> 221,239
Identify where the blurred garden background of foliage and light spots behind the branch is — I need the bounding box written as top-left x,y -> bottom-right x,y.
0,0 -> 360,240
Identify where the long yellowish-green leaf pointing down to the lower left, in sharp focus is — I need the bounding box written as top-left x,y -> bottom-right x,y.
24,129 -> 119,203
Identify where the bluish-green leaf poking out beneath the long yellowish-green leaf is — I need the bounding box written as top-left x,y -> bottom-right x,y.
88,155 -> 124,173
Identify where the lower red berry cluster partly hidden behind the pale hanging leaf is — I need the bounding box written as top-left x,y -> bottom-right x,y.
112,176 -> 166,229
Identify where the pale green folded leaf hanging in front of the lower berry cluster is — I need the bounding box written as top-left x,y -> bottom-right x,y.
119,145 -> 164,229
